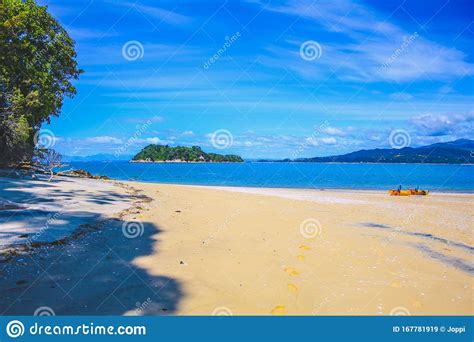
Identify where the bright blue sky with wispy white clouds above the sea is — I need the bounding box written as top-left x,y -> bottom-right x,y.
38,0 -> 474,158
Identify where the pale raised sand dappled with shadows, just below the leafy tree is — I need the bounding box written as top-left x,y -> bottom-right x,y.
0,174 -> 134,246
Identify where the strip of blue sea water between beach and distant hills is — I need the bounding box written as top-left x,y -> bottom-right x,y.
63,162 -> 474,192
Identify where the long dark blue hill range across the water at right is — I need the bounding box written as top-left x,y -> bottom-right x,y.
270,139 -> 474,164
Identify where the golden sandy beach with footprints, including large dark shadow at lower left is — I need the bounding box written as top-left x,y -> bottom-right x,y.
0,179 -> 474,315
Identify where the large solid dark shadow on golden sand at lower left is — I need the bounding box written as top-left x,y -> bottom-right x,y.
0,220 -> 183,315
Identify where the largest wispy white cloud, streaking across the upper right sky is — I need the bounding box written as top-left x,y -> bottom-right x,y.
252,0 -> 474,82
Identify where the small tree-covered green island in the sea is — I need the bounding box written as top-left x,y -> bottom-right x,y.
132,144 -> 244,163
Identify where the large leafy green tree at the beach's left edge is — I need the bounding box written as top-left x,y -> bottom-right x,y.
0,0 -> 82,165
